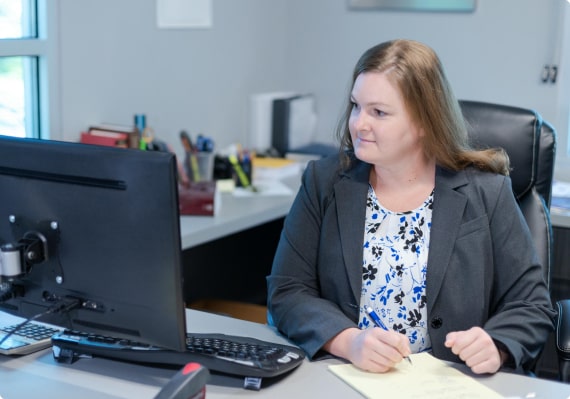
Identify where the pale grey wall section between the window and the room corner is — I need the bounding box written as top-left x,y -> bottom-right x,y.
58,0 -> 289,159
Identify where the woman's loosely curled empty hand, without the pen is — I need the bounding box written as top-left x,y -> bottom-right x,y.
445,327 -> 504,374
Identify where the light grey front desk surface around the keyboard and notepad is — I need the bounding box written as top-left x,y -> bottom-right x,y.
0,310 -> 570,399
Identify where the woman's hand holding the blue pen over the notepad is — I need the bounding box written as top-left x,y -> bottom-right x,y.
324,328 -> 412,373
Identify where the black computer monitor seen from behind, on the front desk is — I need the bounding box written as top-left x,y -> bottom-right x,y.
0,136 -> 185,351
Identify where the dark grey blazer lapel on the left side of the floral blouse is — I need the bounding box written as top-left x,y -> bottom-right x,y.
334,162 -> 370,304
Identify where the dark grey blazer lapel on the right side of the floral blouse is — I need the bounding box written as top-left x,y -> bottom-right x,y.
426,168 -> 467,312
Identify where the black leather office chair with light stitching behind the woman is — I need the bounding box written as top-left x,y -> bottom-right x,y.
460,101 -> 556,379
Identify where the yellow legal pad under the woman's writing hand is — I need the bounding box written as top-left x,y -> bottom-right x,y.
329,353 -> 503,399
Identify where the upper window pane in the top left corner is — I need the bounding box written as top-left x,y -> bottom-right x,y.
0,0 -> 37,39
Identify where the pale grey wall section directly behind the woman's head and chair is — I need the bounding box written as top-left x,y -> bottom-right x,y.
284,0 -> 566,145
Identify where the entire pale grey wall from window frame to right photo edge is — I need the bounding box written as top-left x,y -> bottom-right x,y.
54,0 -> 570,174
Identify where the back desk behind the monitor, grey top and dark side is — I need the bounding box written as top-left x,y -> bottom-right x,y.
180,176 -> 300,305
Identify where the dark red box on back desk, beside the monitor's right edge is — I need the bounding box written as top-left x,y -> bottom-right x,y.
178,181 -> 216,216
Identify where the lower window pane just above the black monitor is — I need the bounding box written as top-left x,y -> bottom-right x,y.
0,57 -> 38,137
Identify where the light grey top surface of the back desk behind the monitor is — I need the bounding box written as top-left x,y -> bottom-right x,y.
180,177 -> 300,249
